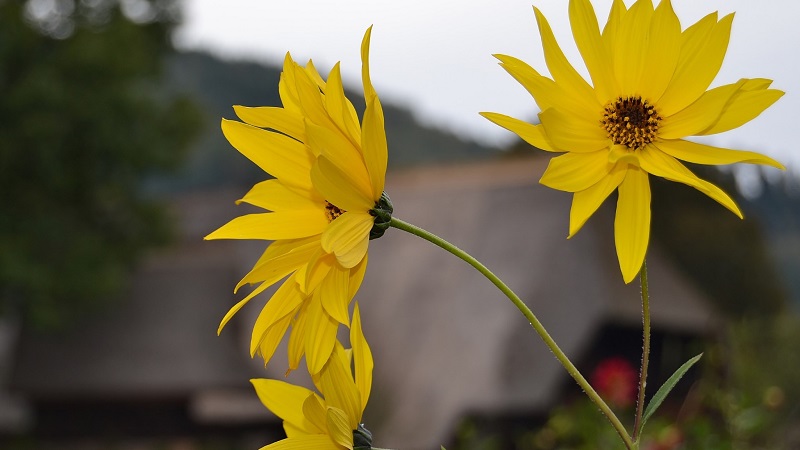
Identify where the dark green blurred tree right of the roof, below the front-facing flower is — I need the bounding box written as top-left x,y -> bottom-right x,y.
650,166 -> 787,318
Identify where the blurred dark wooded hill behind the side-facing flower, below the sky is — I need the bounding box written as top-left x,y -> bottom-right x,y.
148,52 -> 498,192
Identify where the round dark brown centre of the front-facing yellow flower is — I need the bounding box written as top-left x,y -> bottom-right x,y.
600,96 -> 661,150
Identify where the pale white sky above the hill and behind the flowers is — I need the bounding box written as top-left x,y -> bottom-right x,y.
176,0 -> 800,171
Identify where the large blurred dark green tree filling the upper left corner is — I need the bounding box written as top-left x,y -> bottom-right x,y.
0,0 -> 199,327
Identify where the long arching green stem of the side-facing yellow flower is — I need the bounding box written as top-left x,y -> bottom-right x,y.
389,217 -> 634,450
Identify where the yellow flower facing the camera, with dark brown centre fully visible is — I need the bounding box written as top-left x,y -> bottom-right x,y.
482,0 -> 783,283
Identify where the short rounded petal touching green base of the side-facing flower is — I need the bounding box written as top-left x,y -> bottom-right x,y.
321,211 -> 375,269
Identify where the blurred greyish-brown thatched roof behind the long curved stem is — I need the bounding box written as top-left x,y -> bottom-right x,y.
357,159 -> 710,449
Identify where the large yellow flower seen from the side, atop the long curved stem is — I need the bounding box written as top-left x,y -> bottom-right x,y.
206,29 -> 391,374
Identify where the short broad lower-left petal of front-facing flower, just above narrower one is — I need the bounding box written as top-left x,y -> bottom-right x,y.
539,149 -> 614,192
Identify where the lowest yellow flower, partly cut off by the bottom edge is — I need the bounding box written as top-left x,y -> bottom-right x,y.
251,305 -> 373,450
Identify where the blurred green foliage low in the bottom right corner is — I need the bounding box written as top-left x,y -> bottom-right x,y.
448,314 -> 800,450
